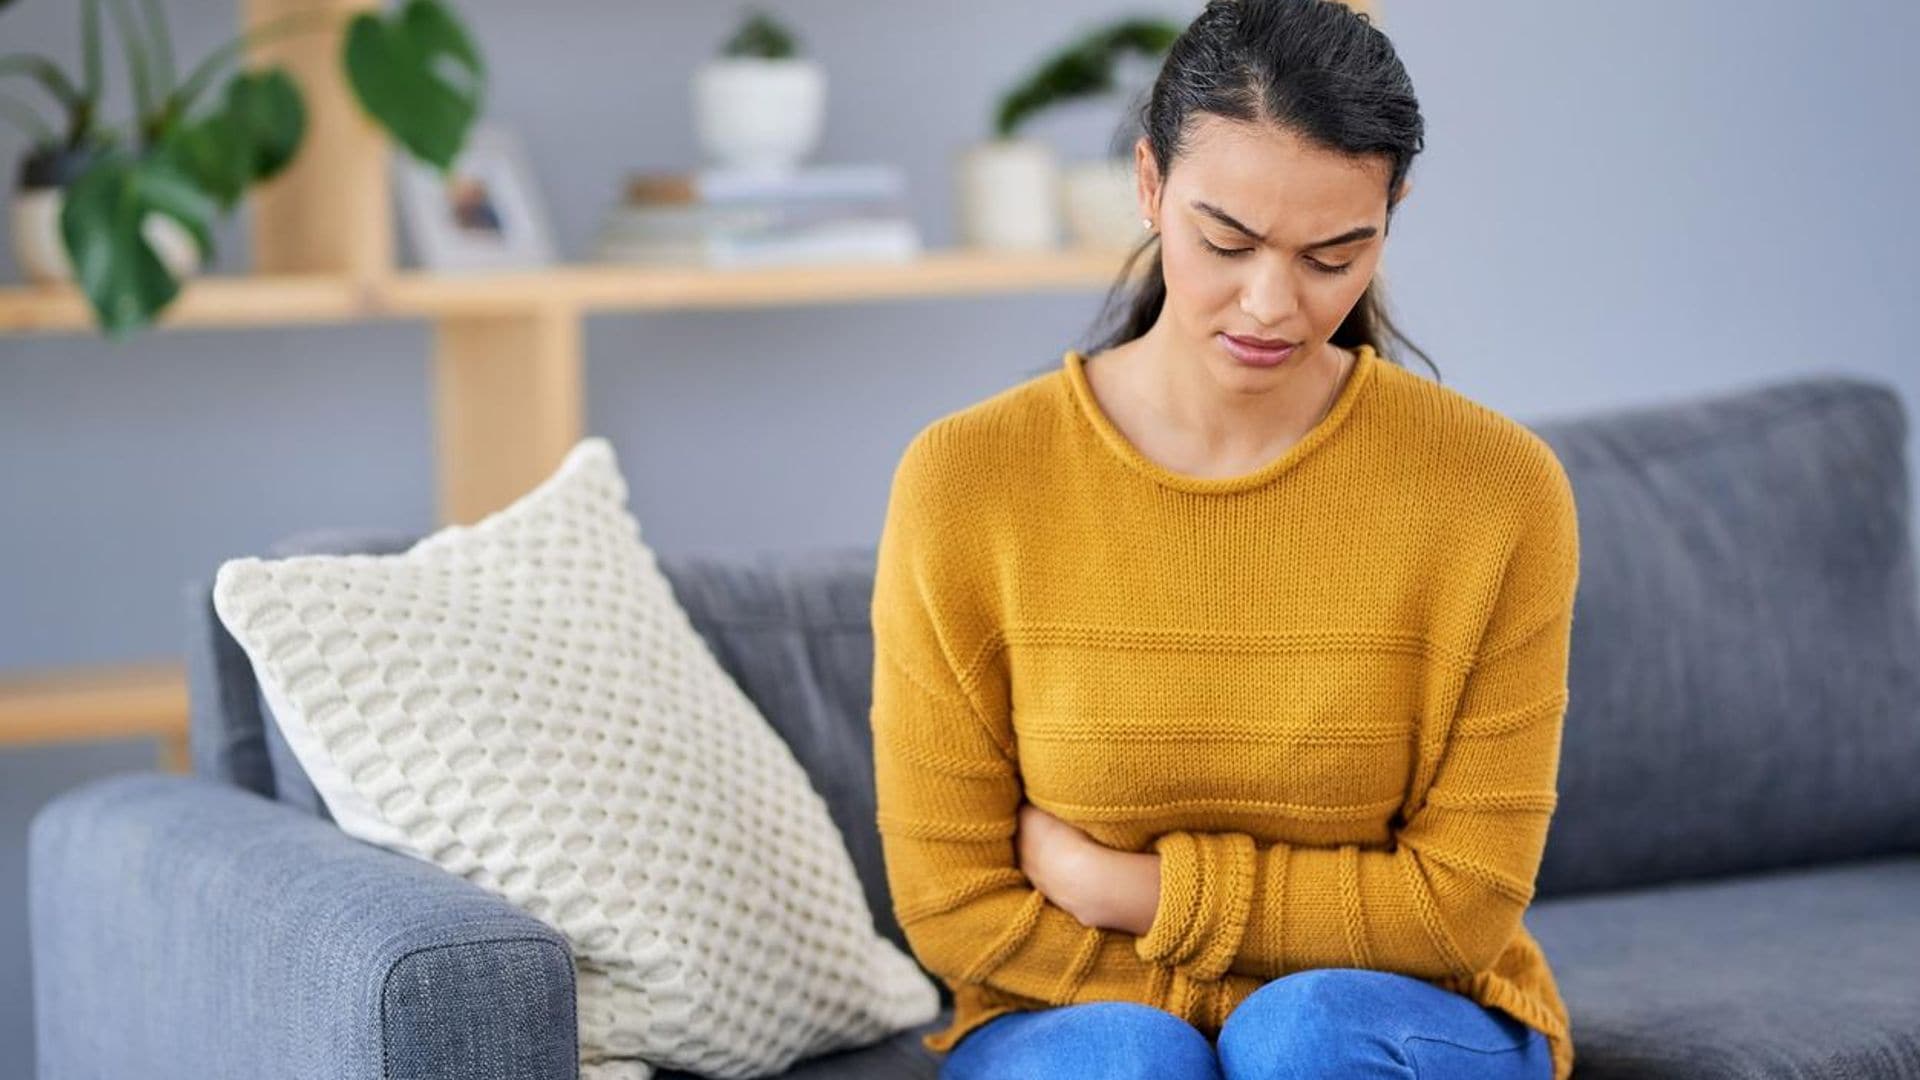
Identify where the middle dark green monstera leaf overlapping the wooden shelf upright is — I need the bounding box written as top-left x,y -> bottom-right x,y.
161,67 -> 307,209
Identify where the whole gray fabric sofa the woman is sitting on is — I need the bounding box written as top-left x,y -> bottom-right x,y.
29,365 -> 1920,1080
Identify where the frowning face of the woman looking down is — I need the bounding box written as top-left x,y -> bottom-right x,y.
1135,113 -> 1405,382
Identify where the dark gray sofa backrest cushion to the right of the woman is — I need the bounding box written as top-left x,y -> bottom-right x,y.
1532,375 -> 1920,896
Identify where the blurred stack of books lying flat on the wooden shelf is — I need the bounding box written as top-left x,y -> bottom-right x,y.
597,163 -> 922,267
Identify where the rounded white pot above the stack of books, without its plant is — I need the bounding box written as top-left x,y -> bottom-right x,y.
693,58 -> 828,169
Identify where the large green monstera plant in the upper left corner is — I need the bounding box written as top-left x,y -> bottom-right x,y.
0,0 -> 486,338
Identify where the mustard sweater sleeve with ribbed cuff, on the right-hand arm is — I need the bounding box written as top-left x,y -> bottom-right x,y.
1137,455 -> 1578,980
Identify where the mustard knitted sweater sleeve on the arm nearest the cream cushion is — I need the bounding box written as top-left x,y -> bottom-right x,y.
870,432 -> 1198,1005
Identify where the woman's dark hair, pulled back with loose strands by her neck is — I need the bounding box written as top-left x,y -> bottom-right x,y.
1081,0 -> 1440,377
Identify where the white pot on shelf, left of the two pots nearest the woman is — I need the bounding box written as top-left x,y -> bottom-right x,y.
954,138 -> 1060,252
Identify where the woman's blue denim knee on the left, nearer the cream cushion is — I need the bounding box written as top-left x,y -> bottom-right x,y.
941,1001 -> 1219,1080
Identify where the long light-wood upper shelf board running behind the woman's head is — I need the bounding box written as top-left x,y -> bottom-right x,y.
0,250 -> 1125,334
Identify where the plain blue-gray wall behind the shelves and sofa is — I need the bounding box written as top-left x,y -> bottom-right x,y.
0,0 -> 1920,1076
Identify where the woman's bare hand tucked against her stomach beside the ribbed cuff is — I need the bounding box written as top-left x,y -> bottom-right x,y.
1016,801 -> 1160,934
